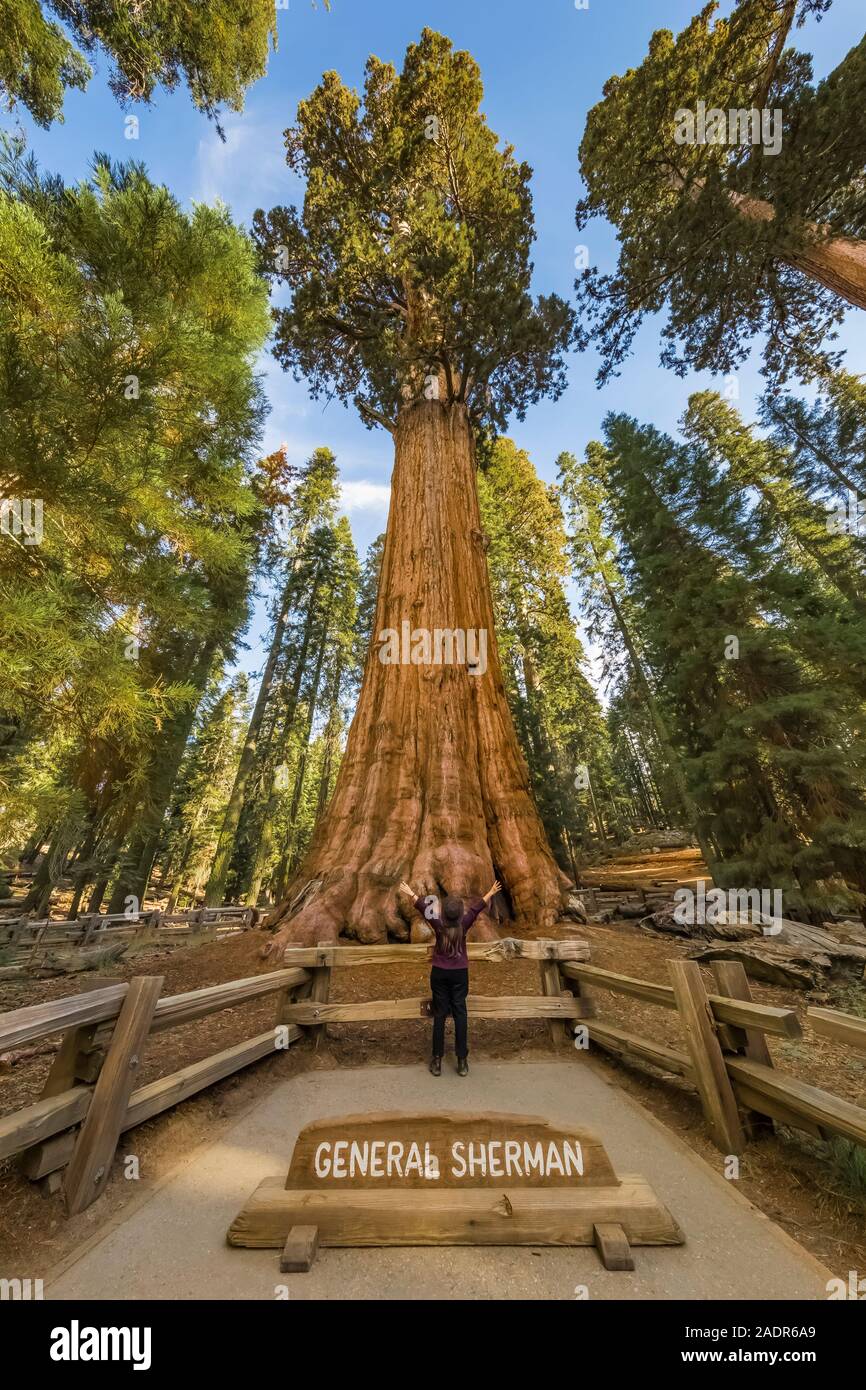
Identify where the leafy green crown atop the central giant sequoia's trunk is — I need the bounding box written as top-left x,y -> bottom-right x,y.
253,29 -> 571,428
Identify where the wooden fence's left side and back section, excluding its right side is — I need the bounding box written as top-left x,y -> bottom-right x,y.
0,940 -> 589,1213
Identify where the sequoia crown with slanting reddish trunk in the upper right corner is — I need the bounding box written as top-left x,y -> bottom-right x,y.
577,0 -> 866,381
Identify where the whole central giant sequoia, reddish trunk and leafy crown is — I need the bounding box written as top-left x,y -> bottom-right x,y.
254,29 -> 571,951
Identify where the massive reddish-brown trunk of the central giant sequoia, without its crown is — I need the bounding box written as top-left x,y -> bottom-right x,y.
270,400 -> 569,951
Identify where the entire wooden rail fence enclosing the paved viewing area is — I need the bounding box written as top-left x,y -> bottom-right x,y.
0,938 -> 866,1213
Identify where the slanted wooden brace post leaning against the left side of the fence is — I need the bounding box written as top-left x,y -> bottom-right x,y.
64,976 -> 163,1216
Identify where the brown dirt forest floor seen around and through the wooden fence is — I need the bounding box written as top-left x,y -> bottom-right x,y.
0,851 -> 866,1277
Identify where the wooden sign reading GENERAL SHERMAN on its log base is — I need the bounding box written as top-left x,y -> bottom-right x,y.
228,1111 -> 683,1269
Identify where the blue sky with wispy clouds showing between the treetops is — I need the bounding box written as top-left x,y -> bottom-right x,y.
3,0 -> 866,683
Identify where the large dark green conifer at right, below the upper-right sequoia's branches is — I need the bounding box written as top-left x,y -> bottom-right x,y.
605,405 -> 866,915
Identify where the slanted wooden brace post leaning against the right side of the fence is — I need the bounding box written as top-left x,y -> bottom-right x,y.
669,960 -> 745,1154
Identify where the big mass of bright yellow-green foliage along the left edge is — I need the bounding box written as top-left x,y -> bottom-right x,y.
0,147 -> 268,895
